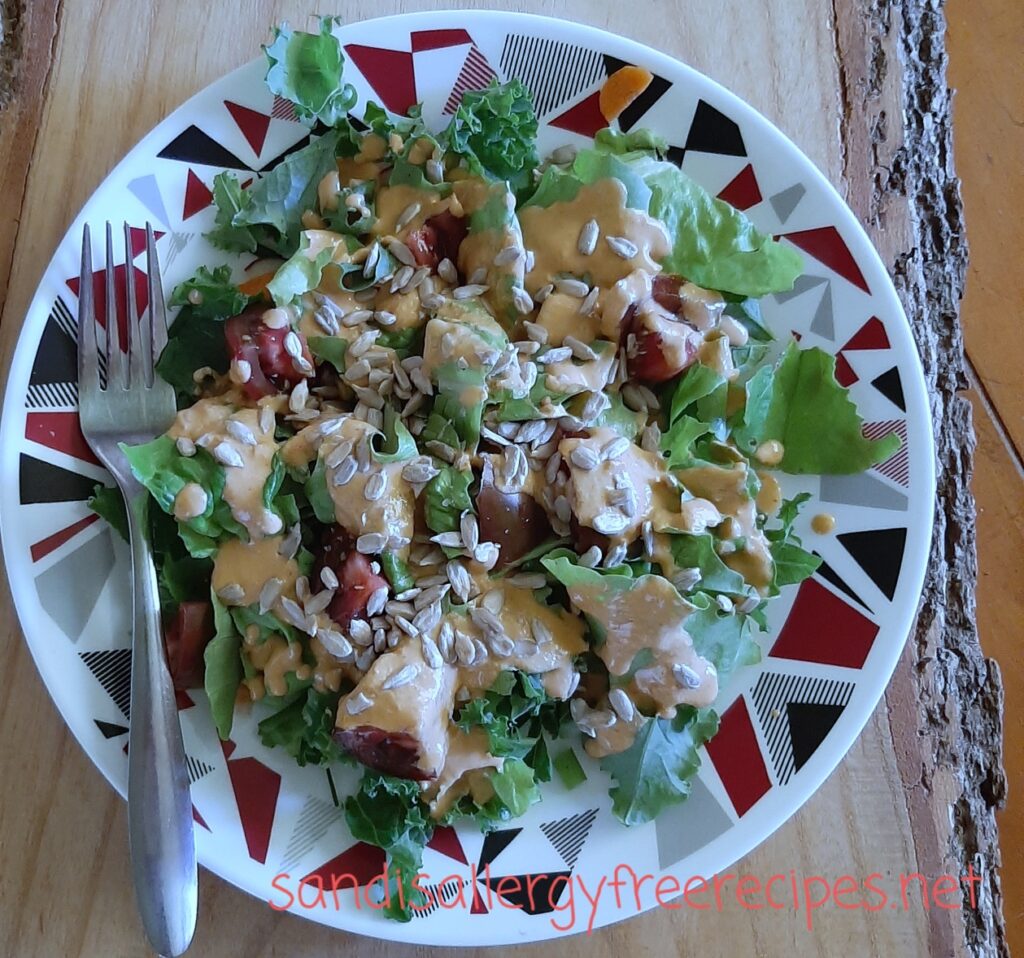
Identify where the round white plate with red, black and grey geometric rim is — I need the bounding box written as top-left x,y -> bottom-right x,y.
0,12 -> 934,945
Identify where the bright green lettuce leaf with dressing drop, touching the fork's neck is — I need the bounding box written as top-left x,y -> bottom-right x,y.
121,435 -> 246,557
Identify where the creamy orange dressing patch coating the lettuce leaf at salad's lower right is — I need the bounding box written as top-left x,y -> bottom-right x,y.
568,575 -> 718,719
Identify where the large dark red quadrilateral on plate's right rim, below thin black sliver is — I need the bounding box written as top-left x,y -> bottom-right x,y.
768,579 -> 879,668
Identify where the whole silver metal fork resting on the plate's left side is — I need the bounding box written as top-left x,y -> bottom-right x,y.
78,223 -> 198,956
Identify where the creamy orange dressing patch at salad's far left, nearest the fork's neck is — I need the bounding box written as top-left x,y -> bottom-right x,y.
167,394 -> 281,539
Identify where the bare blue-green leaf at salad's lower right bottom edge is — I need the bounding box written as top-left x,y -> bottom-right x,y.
601,705 -> 718,825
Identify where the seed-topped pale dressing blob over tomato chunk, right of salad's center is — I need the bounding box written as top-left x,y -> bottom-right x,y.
558,427 -> 680,541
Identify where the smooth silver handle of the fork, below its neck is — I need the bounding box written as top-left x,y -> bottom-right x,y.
122,487 -> 198,958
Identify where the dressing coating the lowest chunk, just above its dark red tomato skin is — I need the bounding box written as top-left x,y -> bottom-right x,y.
336,639 -> 458,779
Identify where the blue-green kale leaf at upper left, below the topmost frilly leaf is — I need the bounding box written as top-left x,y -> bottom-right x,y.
207,130 -> 340,258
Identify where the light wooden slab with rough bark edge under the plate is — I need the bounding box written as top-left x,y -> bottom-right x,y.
0,0 -> 1007,958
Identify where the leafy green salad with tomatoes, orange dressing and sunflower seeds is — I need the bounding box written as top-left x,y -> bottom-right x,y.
91,18 -> 899,919
